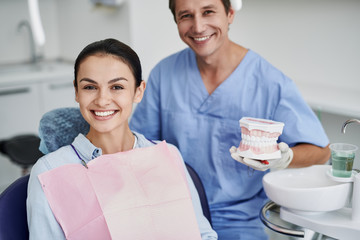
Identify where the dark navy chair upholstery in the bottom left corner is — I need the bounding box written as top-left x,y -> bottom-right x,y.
0,175 -> 29,240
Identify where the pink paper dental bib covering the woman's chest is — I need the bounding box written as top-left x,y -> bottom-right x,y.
39,142 -> 201,240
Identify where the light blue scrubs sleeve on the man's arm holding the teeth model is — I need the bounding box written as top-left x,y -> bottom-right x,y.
274,81 -> 329,147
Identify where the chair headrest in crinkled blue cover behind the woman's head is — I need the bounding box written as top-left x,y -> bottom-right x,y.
39,108 -> 89,154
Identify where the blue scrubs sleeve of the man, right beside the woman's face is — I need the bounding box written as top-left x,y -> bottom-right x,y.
130,69 -> 161,140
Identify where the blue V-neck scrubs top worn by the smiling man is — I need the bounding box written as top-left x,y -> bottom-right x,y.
130,48 -> 329,240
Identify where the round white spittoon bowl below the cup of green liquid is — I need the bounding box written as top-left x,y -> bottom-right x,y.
263,165 -> 352,212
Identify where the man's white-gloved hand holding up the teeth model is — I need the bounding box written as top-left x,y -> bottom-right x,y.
230,142 -> 294,171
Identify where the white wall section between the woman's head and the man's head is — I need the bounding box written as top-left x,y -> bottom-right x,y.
129,0 -> 186,79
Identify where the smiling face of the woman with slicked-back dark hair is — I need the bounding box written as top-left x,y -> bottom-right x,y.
76,55 -> 144,133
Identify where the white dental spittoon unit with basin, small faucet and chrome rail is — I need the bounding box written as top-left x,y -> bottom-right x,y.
260,119 -> 360,240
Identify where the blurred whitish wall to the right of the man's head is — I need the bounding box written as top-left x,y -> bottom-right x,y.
230,0 -> 360,93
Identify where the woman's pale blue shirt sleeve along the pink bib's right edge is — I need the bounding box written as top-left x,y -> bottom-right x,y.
169,144 -> 218,240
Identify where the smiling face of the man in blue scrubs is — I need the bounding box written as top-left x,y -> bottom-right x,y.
175,0 -> 234,57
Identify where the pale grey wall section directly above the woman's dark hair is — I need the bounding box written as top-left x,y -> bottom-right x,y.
57,0 -> 131,61
